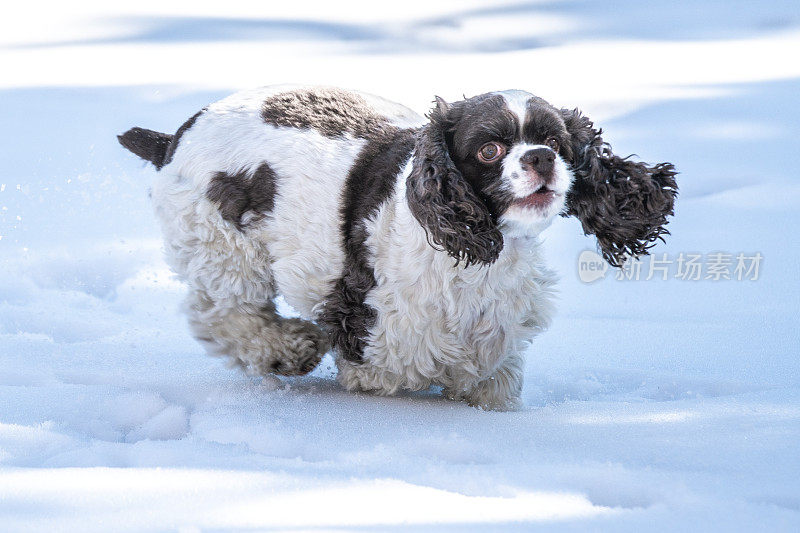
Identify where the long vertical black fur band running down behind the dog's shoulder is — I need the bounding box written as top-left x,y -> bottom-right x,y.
319,127 -> 417,362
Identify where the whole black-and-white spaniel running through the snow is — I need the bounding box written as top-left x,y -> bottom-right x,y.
119,86 -> 677,409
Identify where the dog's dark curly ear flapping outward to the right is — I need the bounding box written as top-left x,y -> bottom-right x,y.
561,109 -> 678,266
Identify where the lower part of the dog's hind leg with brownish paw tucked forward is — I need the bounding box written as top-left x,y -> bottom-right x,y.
186,289 -> 329,376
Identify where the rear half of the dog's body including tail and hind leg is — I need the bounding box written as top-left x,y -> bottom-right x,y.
119,86 -> 424,374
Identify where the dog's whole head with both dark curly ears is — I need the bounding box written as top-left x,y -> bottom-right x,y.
406,91 -> 677,266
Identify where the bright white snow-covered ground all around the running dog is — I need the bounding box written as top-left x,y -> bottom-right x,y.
0,0 -> 800,531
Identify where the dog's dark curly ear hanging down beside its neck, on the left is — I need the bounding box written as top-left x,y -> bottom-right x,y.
406,96 -> 503,266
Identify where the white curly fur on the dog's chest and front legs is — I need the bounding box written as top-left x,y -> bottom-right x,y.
338,167 -> 555,409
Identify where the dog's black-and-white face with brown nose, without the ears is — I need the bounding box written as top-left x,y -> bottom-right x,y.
445,91 -> 572,236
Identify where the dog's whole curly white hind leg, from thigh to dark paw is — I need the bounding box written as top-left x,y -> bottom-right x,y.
153,174 -> 328,375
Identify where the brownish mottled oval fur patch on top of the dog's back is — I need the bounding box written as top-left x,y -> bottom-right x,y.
261,88 -> 388,139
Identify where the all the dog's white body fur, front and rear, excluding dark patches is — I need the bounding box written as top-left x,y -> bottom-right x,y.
147,86 -> 571,409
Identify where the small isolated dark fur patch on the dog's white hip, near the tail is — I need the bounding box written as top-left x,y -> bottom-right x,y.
206,163 -> 275,230
